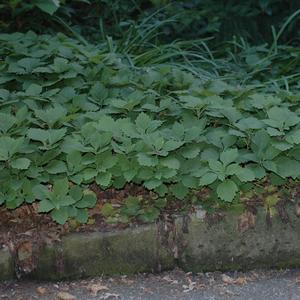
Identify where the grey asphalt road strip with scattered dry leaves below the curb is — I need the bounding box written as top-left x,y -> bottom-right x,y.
0,269 -> 300,300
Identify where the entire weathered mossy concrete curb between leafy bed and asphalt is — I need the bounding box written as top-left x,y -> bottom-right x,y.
0,206 -> 300,280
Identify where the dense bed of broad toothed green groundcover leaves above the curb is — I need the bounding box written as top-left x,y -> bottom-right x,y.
0,32 -> 300,224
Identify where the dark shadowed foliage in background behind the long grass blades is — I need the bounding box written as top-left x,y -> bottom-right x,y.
0,0 -> 300,44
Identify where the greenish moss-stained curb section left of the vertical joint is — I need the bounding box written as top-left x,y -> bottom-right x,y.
33,224 -> 175,279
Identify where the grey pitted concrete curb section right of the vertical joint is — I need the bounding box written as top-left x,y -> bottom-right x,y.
179,209 -> 300,272
